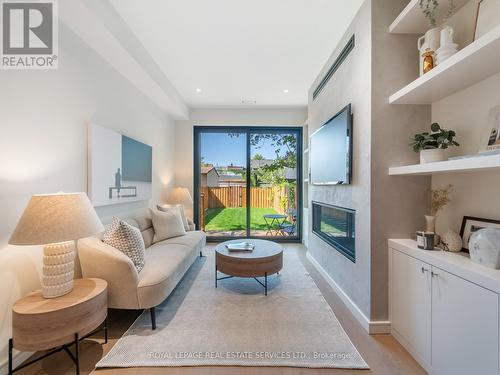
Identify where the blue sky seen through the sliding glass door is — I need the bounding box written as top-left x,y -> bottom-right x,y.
201,133 -> 290,167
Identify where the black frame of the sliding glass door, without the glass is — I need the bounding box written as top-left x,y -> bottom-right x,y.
193,125 -> 303,243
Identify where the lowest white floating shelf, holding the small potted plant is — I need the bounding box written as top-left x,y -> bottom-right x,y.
389,155 -> 500,176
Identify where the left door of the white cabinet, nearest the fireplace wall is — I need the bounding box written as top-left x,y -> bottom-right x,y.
391,250 -> 431,367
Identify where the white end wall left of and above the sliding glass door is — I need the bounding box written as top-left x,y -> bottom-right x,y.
175,107 -> 307,215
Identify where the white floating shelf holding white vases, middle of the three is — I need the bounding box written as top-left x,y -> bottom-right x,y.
389,25 -> 500,104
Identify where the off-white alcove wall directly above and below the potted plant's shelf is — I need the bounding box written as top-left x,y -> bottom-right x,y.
432,74 -> 500,234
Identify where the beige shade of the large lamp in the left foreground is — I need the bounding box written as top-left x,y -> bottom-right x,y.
9,193 -> 104,245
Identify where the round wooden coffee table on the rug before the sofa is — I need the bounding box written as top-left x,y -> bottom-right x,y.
215,239 -> 283,296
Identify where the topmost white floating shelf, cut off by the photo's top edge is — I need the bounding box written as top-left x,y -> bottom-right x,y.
389,0 -> 469,34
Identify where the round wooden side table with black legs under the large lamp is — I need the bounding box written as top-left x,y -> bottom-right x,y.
9,279 -> 108,375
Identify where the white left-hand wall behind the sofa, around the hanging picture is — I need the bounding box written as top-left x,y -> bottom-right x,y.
0,25 -> 175,372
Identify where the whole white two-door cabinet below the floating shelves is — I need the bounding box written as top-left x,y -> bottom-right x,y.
389,244 -> 500,375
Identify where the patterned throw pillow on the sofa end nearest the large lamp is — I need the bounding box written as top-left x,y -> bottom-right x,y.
102,217 -> 146,272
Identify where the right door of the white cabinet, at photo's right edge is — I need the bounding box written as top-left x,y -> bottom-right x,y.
431,267 -> 499,375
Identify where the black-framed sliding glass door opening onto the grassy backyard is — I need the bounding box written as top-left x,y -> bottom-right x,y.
194,127 -> 302,241
